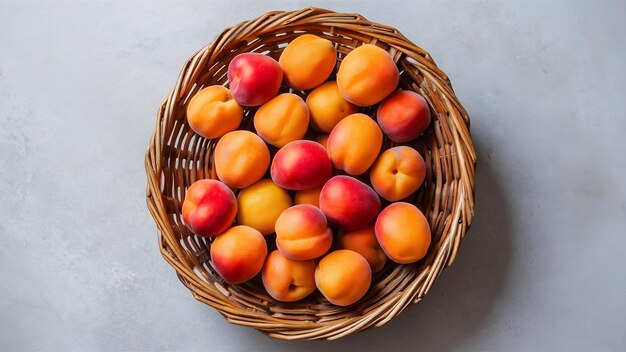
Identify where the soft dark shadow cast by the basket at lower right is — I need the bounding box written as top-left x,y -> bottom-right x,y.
233,126 -> 514,351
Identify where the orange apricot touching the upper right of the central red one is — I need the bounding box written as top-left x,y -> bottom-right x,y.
327,113 -> 383,175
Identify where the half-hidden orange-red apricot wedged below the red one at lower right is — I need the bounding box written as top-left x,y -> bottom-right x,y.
337,225 -> 387,273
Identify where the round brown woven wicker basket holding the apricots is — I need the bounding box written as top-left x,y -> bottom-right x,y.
145,8 -> 476,339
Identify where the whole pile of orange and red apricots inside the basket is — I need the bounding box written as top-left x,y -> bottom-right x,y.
182,34 -> 431,306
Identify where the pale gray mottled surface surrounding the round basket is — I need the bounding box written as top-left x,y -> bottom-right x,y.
0,0 -> 626,351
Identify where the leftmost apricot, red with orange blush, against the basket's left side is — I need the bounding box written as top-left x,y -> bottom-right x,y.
182,180 -> 237,237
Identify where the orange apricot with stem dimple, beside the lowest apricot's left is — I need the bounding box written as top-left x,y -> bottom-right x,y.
261,250 -> 316,302
